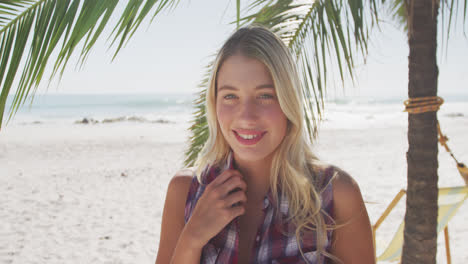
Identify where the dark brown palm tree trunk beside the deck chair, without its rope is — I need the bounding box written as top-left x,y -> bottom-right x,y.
402,0 -> 439,264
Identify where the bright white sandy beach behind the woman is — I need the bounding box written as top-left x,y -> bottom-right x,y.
0,113 -> 468,264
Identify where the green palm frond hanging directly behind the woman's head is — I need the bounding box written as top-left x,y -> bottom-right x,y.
185,0 -> 384,166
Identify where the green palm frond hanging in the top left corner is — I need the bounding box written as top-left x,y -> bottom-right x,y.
0,0 -> 178,128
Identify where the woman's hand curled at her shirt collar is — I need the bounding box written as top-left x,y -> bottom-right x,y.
184,170 -> 247,248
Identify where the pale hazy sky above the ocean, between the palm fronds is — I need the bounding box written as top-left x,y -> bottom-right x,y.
13,0 -> 468,98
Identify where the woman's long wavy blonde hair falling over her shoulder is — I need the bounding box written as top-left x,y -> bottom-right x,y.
196,26 -> 331,262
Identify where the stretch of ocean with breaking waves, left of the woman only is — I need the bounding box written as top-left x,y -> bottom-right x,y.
5,94 -> 196,124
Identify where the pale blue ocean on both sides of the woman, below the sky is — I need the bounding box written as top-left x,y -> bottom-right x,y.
4,93 -> 468,129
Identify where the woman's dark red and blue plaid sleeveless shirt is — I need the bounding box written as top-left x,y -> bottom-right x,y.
185,156 -> 336,264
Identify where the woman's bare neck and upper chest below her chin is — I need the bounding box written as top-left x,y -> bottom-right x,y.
234,154 -> 272,204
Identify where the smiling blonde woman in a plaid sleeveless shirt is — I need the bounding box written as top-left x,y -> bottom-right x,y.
156,27 -> 375,264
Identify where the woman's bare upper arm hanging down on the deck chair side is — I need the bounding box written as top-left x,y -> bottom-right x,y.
331,171 -> 375,264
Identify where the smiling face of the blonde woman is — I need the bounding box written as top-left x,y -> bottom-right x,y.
216,55 -> 288,162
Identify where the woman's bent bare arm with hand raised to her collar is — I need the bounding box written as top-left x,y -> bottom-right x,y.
156,170 -> 247,264
